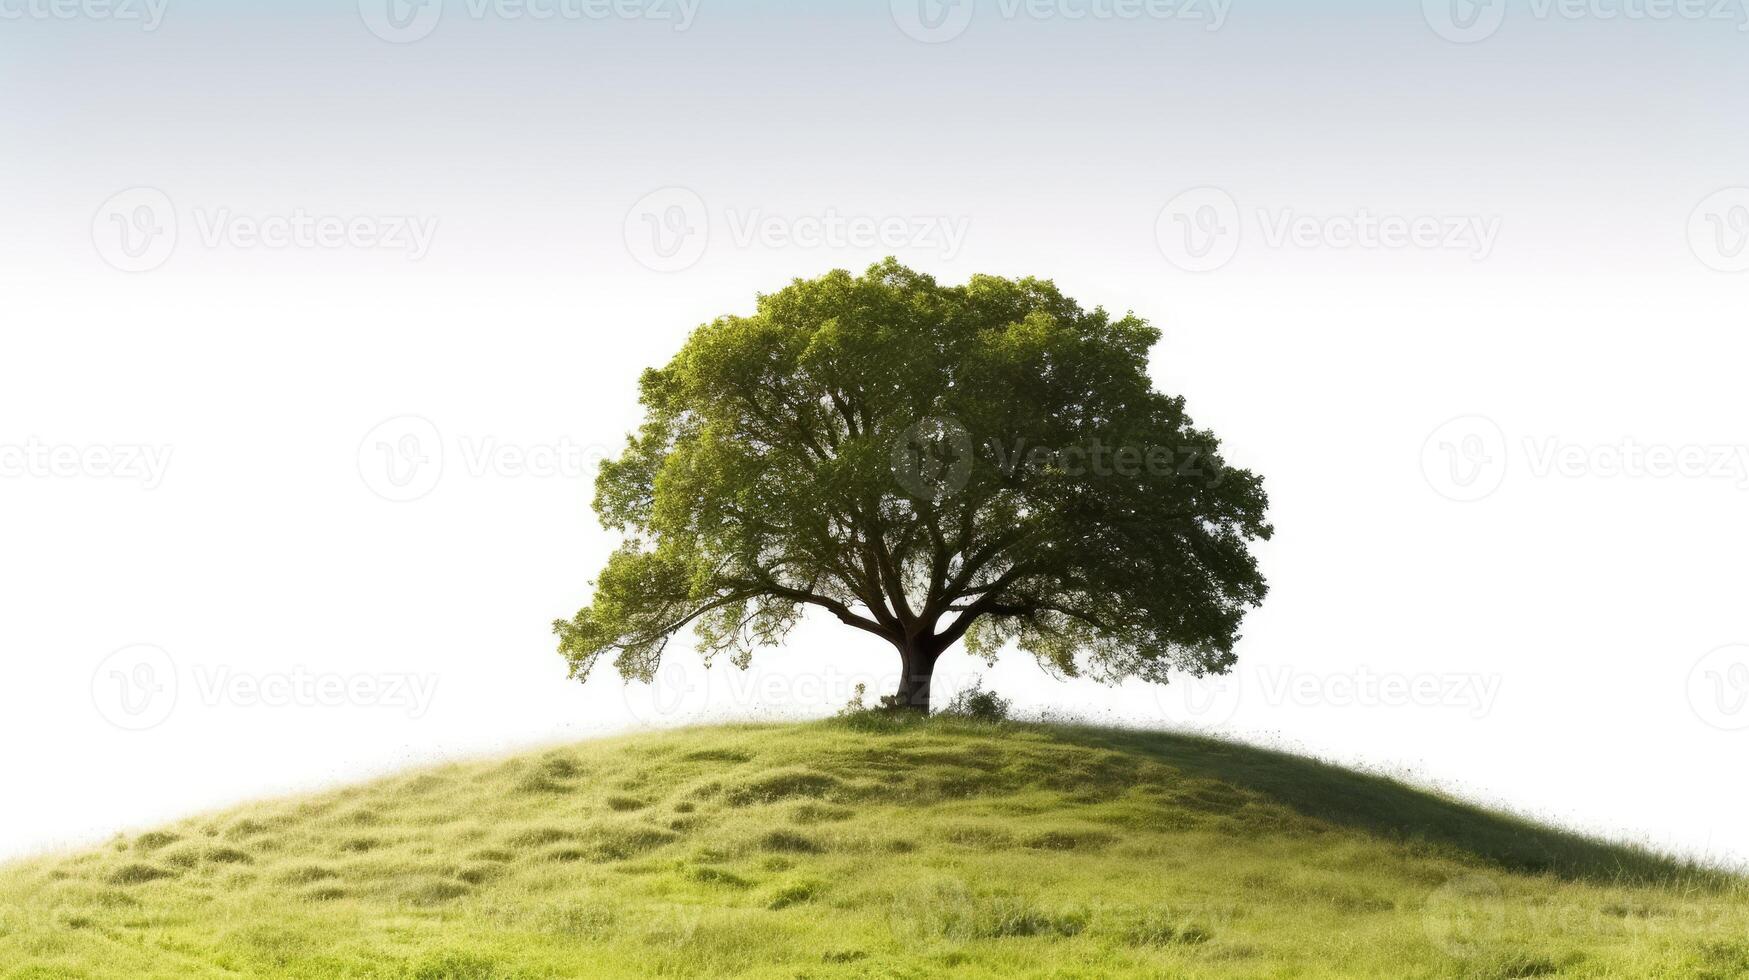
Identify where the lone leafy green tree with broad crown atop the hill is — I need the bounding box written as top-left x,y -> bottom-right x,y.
554,259 -> 1272,712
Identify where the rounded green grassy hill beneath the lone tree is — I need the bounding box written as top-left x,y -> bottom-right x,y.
0,718 -> 1749,980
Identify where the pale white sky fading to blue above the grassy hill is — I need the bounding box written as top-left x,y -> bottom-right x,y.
0,2 -> 1749,861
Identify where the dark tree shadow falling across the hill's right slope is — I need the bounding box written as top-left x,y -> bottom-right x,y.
829,718 -> 1749,891
